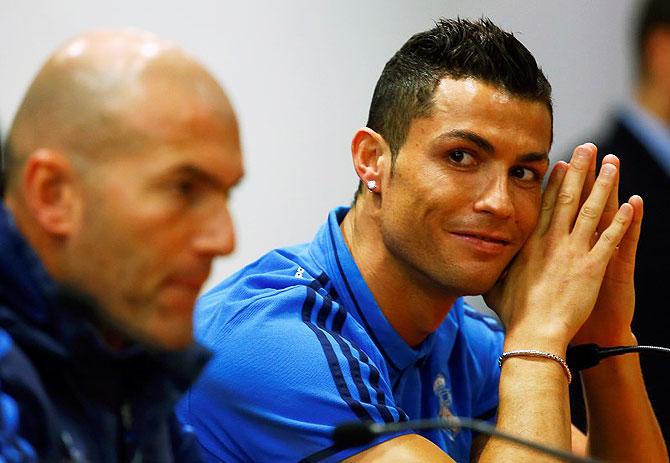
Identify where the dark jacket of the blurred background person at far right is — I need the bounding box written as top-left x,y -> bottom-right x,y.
573,112 -> 670,442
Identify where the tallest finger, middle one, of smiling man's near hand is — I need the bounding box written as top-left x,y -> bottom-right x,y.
552,143 -> 595,232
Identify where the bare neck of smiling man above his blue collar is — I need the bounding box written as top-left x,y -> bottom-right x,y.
340,198 -> 457,347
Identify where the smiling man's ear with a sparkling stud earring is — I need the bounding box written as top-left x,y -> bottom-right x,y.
351,127 -> 391,191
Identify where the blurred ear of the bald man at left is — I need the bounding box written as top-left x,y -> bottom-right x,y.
23,148 -> 78,237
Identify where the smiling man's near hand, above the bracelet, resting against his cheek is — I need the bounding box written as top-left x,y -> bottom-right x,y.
487,144 -> 641,355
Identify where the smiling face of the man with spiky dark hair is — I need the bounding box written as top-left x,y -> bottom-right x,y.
380,78 -> 552,295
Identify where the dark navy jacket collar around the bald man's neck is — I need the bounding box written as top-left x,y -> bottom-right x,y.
0,206 -> 210,402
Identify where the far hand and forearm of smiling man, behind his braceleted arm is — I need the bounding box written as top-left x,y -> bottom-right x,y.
560,150 -> 668,463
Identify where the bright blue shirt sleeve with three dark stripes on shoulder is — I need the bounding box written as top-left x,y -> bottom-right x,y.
179,286 -> 407,462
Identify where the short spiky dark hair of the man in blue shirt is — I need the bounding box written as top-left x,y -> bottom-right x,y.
366,18 -> 552,179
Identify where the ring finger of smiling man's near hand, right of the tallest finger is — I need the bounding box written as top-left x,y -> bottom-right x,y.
573,163 -> 617,242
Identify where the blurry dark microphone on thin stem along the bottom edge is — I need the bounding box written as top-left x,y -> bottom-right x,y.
332,416 -> 600,463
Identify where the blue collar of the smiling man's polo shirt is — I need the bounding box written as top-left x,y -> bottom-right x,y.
315,207 -> 462,372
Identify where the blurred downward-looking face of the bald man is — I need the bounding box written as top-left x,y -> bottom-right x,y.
66,92 -> 242,349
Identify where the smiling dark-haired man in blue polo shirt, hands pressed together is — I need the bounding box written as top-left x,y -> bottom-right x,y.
179,16 -> 667,462
